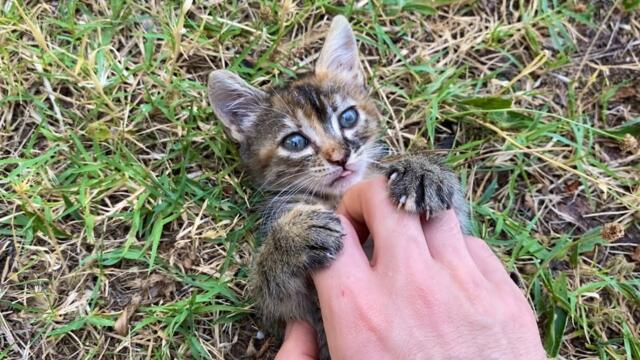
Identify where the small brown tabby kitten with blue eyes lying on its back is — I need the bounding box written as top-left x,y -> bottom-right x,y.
208,16 -> 466,358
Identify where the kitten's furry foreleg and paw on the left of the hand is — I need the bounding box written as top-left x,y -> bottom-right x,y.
249,204 -> 343,323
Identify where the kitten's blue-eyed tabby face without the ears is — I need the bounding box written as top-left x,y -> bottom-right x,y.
243,75 -> 378,193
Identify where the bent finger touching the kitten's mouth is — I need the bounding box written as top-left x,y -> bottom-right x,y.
338,177 -> 429,267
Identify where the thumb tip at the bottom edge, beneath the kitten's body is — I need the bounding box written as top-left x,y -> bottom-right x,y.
276,320 -> 318,360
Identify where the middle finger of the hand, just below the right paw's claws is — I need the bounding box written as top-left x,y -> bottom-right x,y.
422,210 -> 475,268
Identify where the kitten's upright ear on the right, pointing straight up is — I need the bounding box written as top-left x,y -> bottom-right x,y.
316,15 -> 364,86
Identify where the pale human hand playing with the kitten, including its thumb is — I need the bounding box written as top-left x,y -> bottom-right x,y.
276,178 -> 546,360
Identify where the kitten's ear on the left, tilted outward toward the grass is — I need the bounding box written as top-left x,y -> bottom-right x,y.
208,70 -> 266,142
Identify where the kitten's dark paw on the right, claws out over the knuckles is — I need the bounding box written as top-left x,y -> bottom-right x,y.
387,156 -> 461,216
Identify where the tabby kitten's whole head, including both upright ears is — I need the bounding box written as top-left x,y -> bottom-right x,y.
209,16 -> 378,194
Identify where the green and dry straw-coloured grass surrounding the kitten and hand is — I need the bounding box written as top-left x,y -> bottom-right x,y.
0,0 -> 640,359
